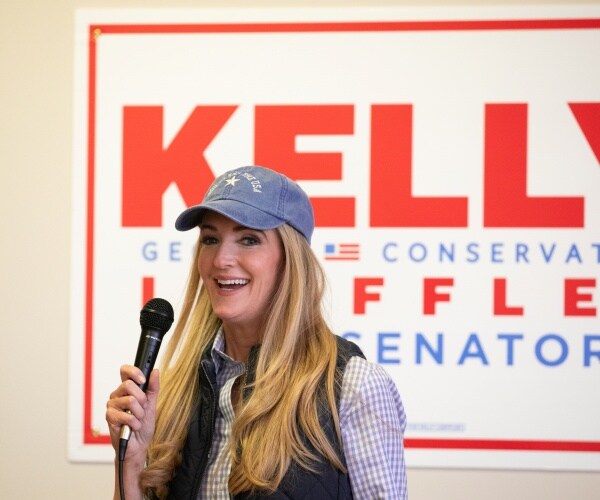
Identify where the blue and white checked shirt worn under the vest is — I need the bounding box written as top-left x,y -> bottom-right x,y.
199,331 -> 408,500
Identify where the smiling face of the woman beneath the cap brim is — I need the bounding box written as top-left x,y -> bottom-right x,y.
198,211 -> 283,333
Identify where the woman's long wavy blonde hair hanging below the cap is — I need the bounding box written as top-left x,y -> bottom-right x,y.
141,224 -> 344,498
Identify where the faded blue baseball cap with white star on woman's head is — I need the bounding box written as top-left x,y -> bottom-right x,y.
175,166 -> 315,243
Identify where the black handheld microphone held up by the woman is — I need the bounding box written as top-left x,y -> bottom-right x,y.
119,298 -> 173,448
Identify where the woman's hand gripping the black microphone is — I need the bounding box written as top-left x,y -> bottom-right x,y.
106,365 -> 160,466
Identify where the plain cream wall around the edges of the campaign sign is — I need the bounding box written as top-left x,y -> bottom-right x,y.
0,0 -> 600,500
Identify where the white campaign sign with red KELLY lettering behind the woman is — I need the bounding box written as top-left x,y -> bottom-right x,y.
69,6 -> 600,470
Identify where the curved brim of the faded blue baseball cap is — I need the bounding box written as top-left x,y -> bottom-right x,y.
175,200 -> 285,231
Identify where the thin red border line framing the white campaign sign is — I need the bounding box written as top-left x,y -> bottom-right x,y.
83,18 -> 600,452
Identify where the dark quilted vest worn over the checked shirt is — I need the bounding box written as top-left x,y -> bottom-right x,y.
168,337 -> 364,500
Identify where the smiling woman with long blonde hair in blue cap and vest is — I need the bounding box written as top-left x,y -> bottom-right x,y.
106,166 -> 406,500
